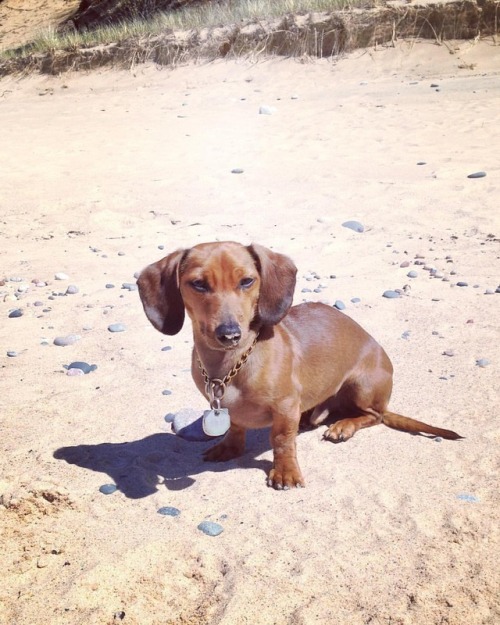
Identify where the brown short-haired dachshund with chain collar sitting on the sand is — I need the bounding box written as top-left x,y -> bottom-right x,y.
138,242 -> 462,489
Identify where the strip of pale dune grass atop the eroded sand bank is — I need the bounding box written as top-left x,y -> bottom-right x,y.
0,0 -> 373,60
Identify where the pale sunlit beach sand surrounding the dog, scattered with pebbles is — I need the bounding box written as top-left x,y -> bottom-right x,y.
0,41 -> 500,625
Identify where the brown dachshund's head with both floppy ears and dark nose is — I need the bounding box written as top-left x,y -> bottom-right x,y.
137,242 -> 297,349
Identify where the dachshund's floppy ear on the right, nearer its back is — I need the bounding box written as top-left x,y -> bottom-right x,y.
247,243 -> 297,325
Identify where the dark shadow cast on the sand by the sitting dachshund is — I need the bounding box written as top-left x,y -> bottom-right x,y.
54,429 -> 272,499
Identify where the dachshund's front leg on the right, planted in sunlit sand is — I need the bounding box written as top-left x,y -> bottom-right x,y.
267,407 -> 305,490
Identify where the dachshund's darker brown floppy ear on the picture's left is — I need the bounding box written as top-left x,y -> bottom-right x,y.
137,250 -> 187,334
